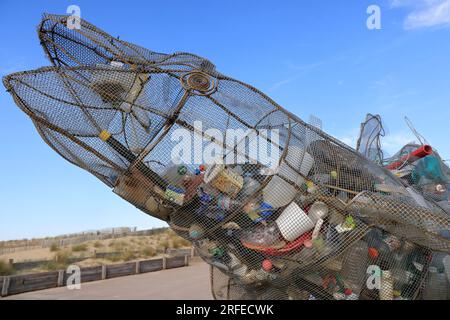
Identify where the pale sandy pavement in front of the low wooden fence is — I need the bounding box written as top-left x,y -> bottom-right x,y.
0,258 -> 212,300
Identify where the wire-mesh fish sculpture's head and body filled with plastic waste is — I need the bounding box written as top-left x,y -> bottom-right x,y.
3,15 -> 450,300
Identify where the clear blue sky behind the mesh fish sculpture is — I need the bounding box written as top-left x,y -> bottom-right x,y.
0,0 -> 450,240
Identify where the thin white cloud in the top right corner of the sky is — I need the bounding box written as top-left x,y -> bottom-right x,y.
391,0 -> 450,30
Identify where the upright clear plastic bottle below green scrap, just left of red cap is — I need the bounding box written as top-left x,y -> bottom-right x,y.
341,240 -> 369,295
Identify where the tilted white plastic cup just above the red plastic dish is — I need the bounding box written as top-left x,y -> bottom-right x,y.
275,202 -> 314,241
